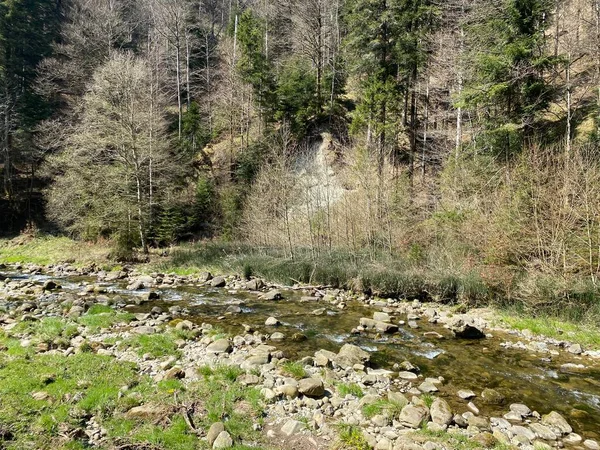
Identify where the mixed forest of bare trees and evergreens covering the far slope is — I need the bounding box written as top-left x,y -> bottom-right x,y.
0,0 -> 600,317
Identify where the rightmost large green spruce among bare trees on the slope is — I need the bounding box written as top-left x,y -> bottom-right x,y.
462,0 -> 558,157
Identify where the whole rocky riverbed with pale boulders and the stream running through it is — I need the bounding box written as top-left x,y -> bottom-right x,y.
0,265 -> 600,450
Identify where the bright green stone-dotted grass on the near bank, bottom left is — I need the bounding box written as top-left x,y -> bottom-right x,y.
0,318 -> 264,450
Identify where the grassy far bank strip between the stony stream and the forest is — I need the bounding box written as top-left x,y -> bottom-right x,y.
0,235 -> 600,348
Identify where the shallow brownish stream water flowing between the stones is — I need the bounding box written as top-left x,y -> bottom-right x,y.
0,273 -> 600,439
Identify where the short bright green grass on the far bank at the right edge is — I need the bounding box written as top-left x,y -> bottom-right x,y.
501,312 -> 600,348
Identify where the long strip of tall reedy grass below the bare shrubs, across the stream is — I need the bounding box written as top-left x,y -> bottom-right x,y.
157,242 -> 491,300
